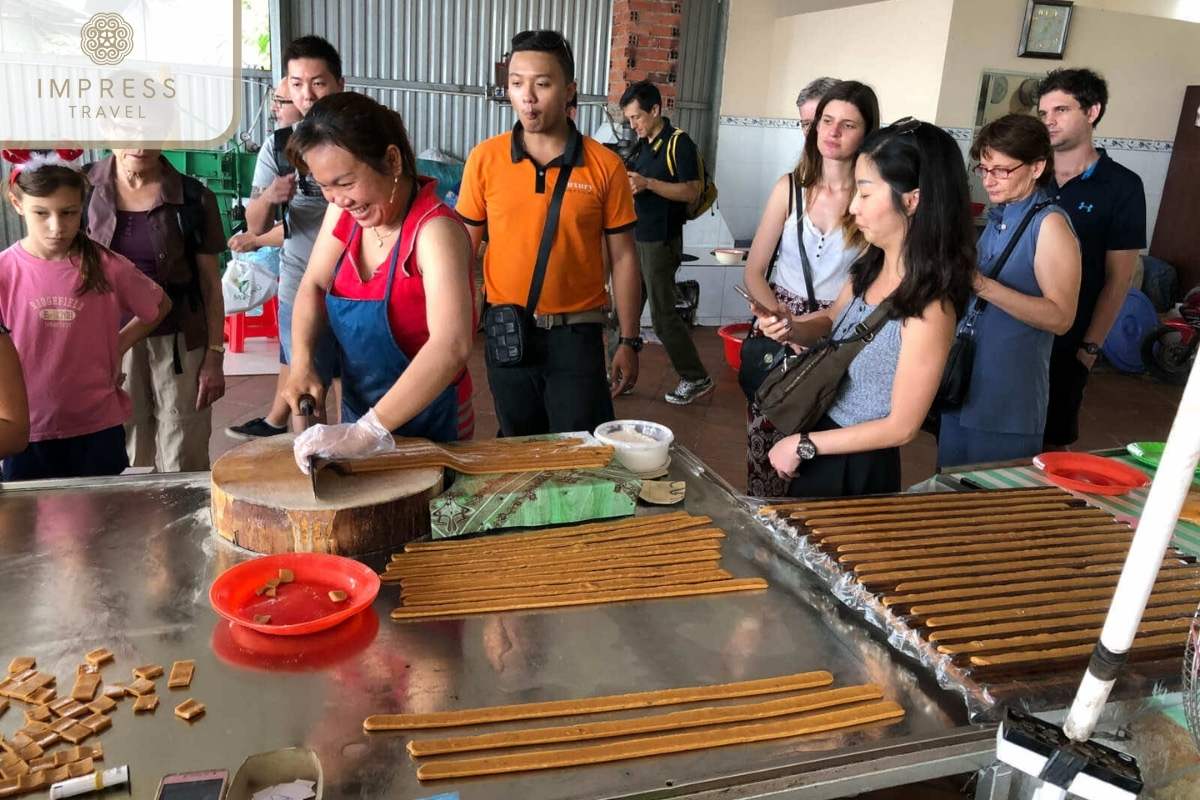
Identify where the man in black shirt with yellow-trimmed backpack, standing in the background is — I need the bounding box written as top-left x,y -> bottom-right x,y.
620,80 -> 715,405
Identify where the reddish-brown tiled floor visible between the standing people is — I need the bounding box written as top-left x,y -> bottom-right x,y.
209,327 -> 1182,491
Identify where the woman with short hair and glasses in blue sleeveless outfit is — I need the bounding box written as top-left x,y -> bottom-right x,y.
937,114 -> 1086,467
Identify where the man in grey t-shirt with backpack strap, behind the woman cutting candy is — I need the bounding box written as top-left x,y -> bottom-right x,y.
226,36 -> 346,439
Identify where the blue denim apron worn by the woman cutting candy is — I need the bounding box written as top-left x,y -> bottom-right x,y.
325,224 -> 458,441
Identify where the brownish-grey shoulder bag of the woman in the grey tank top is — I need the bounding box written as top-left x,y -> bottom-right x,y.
756,296 -> 892,435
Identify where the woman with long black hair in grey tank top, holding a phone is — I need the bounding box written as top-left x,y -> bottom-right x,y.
760,118 -> 974,497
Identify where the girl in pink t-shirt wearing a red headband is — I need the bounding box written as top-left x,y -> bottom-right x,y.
0,150 -> 170,481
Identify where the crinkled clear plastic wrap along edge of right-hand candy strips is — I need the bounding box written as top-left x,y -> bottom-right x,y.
748,510 -> 1178,723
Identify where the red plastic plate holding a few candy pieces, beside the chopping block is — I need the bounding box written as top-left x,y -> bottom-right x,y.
209,553 -> 379,636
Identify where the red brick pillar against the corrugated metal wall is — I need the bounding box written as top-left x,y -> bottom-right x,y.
608,0 -> 683,115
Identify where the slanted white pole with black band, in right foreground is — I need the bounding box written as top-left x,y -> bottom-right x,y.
1063,369 -> 1200,741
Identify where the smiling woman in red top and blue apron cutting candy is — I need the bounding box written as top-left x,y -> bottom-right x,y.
283,92 -> 474,469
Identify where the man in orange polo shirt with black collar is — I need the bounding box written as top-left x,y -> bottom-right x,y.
457,31 -> 642,437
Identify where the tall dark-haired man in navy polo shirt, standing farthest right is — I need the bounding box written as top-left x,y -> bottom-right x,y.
1038,70 -> 1146,450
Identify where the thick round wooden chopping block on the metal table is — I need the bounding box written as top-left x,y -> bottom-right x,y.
212,434 -> 443,555
